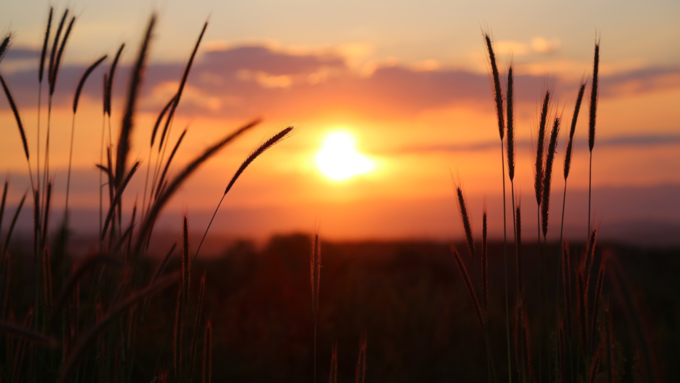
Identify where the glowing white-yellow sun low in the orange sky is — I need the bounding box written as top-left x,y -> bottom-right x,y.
316,131 -> 375,181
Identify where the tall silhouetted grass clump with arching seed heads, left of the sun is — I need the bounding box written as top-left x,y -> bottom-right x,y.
0,8 -> 292,382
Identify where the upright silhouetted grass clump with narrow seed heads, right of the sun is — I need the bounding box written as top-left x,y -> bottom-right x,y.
451,34 -> 658,382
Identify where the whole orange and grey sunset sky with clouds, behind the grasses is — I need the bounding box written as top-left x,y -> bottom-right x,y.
0,0 -> 680,244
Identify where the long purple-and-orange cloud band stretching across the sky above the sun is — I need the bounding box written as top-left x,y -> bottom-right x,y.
0,41 -> 680,119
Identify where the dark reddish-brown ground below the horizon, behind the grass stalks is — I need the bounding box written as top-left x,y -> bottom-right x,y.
2,235 -> 680,382
